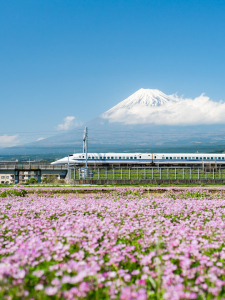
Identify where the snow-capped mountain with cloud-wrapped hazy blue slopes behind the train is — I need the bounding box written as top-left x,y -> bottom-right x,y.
0,89 -> 225,153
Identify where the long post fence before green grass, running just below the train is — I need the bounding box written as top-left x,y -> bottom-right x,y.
68,167 -> 225,180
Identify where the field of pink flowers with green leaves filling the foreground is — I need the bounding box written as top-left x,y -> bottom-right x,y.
0,188 -> 225,300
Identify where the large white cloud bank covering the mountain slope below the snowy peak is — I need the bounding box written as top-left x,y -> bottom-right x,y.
103,94 -> 225,125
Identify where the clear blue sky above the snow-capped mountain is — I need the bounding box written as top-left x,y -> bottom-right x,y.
0,0 -> 225,147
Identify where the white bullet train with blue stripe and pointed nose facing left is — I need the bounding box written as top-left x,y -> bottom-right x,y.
52,153 -> 225,166
